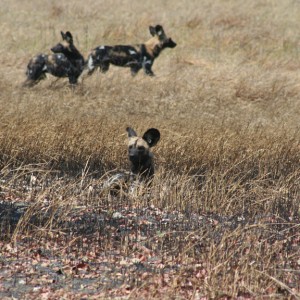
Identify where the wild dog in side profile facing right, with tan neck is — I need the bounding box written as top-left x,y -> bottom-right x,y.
84,25 -> 176,76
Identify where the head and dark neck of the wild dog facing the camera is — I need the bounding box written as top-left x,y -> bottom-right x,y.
126,127 -> 160,177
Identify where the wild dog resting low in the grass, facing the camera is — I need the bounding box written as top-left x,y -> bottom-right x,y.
104,127 -> 160,195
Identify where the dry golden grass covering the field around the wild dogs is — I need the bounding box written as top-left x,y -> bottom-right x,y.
0,0 -> 300,299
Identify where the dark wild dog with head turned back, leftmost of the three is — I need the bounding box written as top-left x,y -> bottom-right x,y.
24,31 -> 84,87
